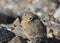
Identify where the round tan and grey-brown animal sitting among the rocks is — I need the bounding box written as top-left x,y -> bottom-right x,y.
21,12 -> 46,43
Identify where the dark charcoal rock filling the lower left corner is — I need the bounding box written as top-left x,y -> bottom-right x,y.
0,29 -> 15,43
